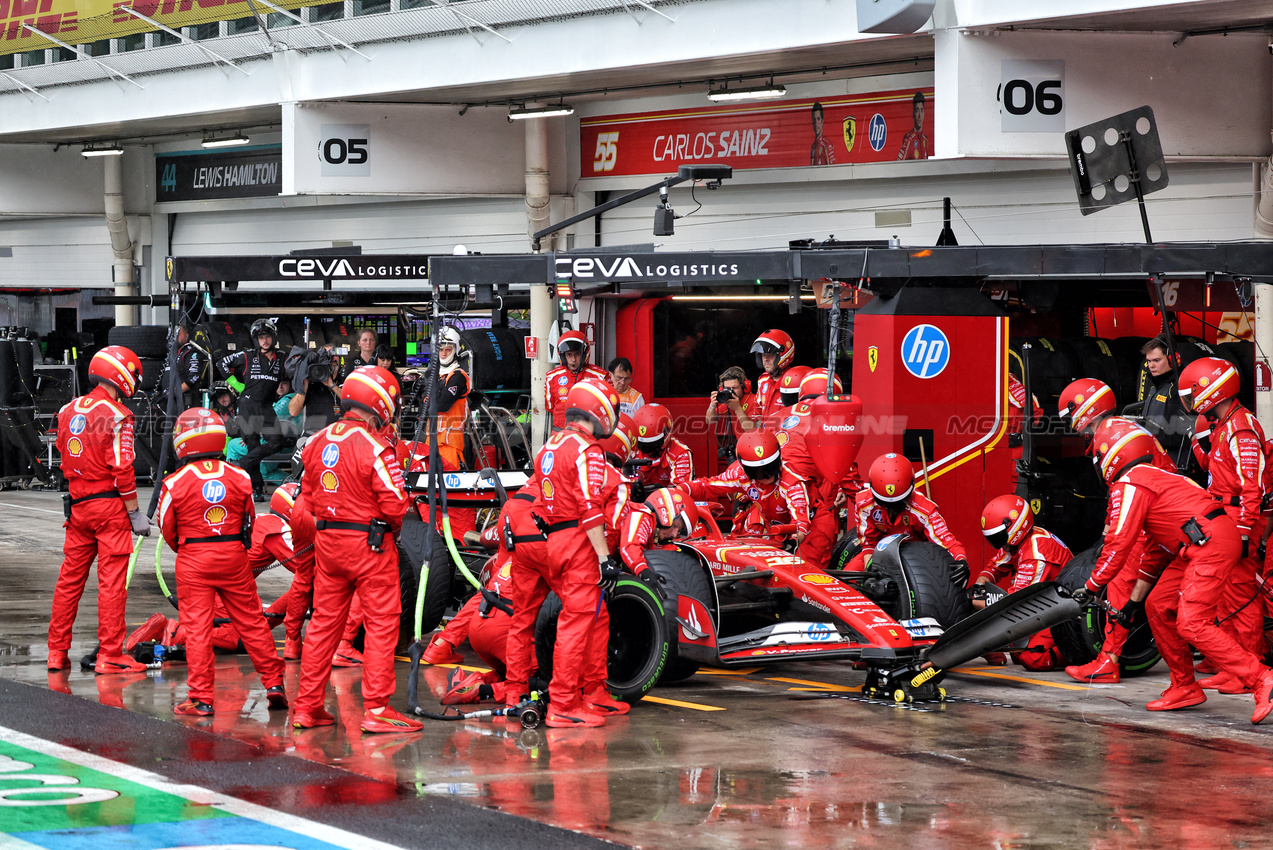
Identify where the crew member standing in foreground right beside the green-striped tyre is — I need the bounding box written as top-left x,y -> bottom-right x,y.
507,380 -> 621,728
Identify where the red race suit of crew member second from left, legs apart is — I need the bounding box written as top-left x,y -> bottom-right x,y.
158,459 -> 283,705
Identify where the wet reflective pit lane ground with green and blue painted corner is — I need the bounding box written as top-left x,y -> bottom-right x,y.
0,483 -> 1273,850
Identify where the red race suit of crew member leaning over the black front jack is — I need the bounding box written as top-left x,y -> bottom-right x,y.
1087,463 -> 1264,686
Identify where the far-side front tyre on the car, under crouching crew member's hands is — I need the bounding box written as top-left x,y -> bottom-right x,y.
867,538 -> 973,629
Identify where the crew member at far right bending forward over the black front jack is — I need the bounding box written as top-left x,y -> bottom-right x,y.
1074,429 -> 1273,723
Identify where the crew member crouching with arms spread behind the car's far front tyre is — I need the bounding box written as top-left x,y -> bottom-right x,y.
849,452 -> 969,588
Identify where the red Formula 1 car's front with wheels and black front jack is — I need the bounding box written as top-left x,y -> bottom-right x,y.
536,523 -> 1080,701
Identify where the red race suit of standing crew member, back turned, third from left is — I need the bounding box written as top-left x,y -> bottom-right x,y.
297,414 -> 409,713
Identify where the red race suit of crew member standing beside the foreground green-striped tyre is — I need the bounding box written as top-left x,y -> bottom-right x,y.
508,425 -> 610,714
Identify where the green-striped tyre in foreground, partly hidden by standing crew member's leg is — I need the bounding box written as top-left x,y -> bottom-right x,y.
535,578 -> 675,702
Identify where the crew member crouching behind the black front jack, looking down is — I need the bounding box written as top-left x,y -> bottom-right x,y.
973,496 -> 1073,671
